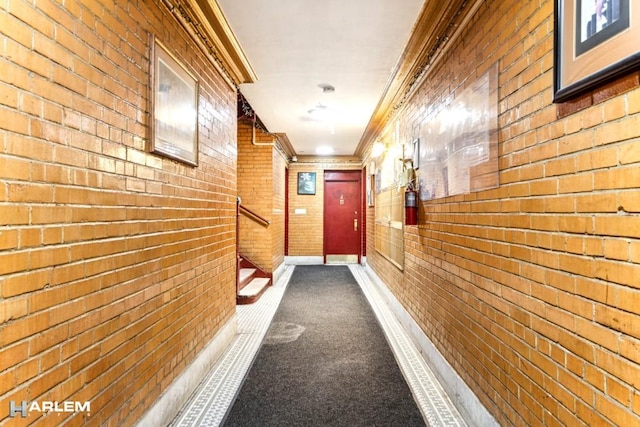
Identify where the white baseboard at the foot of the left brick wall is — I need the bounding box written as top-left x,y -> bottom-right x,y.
137,315 -> 238,427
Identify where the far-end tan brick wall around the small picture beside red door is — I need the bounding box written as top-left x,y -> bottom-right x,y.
289,158 -> 364,256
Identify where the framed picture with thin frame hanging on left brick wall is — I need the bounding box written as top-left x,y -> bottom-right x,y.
149,36 -> 198,166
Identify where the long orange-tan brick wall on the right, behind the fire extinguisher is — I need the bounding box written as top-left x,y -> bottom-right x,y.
367,0 -> 640,426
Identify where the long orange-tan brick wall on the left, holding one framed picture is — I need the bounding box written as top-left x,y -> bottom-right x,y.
0,0 -> 236,425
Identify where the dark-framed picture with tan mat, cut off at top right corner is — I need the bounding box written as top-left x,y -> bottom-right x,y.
553,0 -> 640,102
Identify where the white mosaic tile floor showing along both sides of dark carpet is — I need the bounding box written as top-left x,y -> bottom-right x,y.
171,264 -> 467,427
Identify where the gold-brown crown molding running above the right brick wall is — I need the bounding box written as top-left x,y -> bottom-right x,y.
354,0 -> 483,158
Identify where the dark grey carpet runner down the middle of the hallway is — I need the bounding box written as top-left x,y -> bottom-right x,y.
224,265 -> 425,427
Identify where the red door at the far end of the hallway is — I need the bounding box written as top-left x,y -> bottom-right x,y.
324,171 -> 363,262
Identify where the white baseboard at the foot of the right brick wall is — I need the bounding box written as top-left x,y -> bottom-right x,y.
363,265 -> 499,427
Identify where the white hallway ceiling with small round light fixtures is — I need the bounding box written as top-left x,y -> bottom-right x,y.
217,0 -> 423,155
